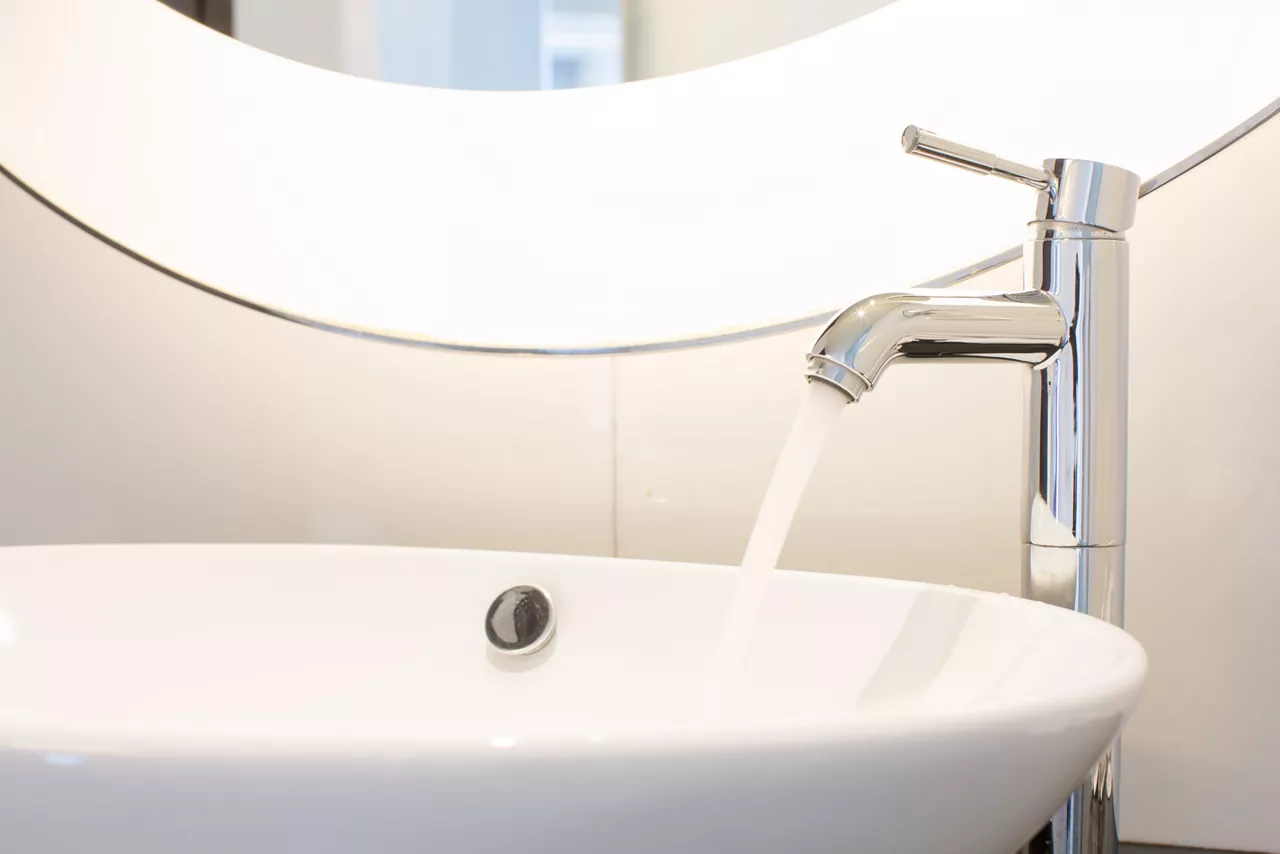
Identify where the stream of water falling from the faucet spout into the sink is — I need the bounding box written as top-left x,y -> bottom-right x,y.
705,383 -> 849,716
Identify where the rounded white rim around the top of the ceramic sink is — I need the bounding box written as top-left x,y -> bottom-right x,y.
0,543 -> 1148,761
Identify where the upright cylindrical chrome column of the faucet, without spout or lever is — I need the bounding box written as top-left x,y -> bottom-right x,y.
1023,147 -> 1139,854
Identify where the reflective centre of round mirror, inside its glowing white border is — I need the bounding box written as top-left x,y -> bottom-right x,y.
161,0 -> 892,90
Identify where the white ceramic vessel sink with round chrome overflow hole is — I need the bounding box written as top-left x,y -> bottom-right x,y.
0,545 -> 1146,854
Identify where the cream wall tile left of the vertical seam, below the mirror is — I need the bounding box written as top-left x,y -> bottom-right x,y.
0,188 -> 613,554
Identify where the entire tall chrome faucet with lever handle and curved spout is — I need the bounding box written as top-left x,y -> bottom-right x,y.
805,125 -> 1139,854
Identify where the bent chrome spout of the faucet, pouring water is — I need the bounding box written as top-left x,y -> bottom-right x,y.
805,291 -> 1068,402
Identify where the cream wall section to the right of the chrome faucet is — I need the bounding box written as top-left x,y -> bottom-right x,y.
1121,120 -> 1280,851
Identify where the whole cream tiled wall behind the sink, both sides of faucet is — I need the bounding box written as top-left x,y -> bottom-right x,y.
0,122 -> 1280,851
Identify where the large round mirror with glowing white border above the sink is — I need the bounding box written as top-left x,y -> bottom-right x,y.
0,0 -> 1280,353
